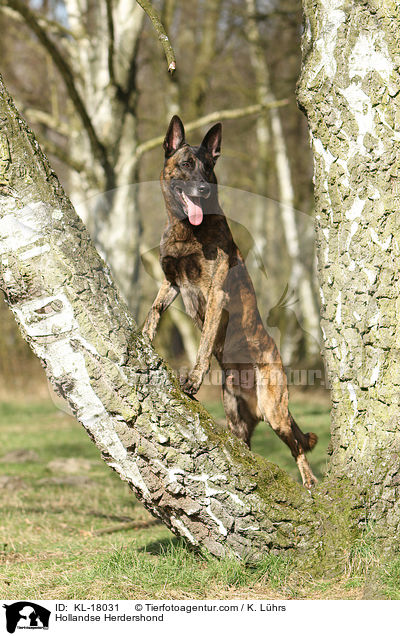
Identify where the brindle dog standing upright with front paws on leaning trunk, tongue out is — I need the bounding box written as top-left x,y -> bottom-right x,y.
143,116 -> 317,488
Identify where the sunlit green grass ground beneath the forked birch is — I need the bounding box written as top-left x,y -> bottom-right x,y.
0,398 -> 394,599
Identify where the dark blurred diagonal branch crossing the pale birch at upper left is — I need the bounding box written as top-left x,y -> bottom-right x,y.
0,0 -> 112,184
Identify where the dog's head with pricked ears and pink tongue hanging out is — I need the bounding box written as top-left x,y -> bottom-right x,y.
161,115 -> 222,225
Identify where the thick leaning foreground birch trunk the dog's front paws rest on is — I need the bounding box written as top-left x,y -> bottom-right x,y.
0,74 -> 320,559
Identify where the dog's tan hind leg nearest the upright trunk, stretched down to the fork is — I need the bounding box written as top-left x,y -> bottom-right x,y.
256,365 -> 318,488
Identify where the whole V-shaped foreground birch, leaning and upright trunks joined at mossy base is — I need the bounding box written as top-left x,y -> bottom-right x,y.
0,0 -> 400,572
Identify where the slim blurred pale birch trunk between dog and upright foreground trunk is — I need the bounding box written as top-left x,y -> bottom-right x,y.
246,0 -> 319,364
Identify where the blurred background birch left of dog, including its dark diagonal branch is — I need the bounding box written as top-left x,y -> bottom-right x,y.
0,0 -> 145,315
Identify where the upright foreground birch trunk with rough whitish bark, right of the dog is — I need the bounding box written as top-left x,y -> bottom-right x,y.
299,0 -> 400,536
